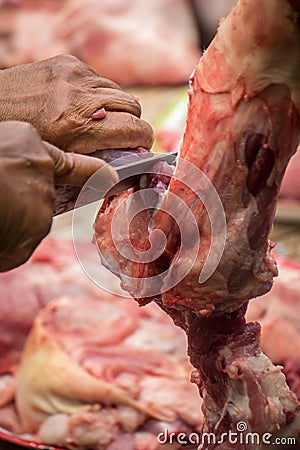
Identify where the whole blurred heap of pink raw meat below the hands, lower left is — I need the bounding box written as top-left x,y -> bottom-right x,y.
0,239 -> 201,450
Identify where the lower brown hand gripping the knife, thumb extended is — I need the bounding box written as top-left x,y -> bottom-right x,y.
0,121 -> 117,272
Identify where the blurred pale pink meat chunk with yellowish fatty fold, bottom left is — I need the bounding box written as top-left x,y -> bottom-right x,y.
16,293 -> 199,449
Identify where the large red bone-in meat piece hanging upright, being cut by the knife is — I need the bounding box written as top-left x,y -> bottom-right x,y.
95,0 -> 300,450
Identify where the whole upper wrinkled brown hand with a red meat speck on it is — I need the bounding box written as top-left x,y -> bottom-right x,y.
0,55 -> 153,153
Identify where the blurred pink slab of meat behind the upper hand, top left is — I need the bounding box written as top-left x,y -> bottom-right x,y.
0,0 -> 200,85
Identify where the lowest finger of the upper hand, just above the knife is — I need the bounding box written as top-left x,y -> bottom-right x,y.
64,111 -> 153,154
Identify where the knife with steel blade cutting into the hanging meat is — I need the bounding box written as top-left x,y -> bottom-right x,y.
53,150 -> 178,216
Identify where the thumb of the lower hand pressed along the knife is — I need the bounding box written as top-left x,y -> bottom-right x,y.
44,142 -> 118,190
